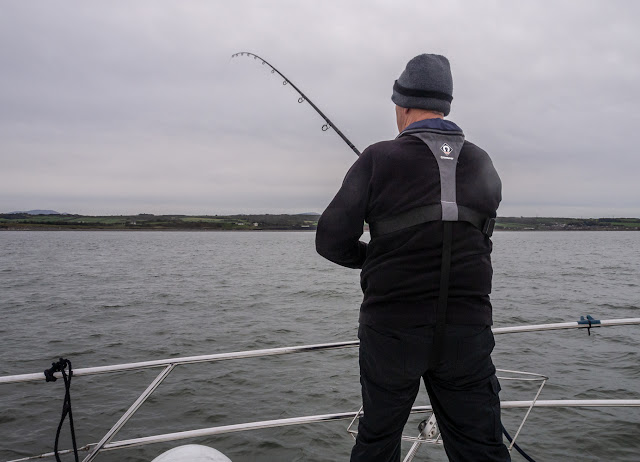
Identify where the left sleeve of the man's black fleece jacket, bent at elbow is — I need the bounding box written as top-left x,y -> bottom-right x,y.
316,151 -> 372,268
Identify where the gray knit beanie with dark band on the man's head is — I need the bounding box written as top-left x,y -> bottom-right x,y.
391,54 -> 453,115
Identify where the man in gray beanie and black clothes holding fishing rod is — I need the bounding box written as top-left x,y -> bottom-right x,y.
316,54 -> 510,462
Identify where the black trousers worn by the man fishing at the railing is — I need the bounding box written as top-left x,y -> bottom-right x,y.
351,324 -> 511,462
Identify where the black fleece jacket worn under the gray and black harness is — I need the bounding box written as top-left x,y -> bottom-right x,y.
316,124 -> 501,327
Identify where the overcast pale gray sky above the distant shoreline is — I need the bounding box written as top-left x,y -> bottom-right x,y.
0,0 -> 640,217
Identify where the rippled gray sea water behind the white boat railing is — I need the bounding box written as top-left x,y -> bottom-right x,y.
0,231 -> 640,462
